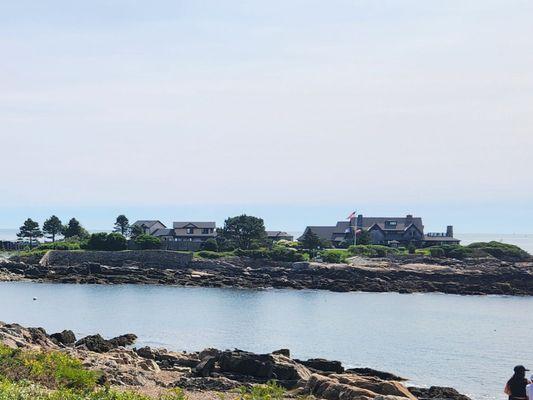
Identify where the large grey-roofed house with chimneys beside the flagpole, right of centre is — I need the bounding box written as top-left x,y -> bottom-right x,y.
298,214 -> 460,246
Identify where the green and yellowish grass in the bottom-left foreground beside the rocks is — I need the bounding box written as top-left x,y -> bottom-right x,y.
0,344 -> 186,400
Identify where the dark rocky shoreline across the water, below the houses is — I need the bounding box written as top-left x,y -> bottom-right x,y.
0,257 -> 533,296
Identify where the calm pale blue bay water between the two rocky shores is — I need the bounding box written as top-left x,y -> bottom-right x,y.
0,282 -> 533,399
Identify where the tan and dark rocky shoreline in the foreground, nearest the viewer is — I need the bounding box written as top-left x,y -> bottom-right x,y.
0,322 -> 469,400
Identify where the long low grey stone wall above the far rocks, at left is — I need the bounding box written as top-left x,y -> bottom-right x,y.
40,250 -> 192,269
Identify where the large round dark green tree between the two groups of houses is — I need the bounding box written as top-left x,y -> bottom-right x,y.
222,214 -> 266,250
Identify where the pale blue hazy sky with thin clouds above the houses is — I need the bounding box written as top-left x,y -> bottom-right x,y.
0,0 -> 533,233
